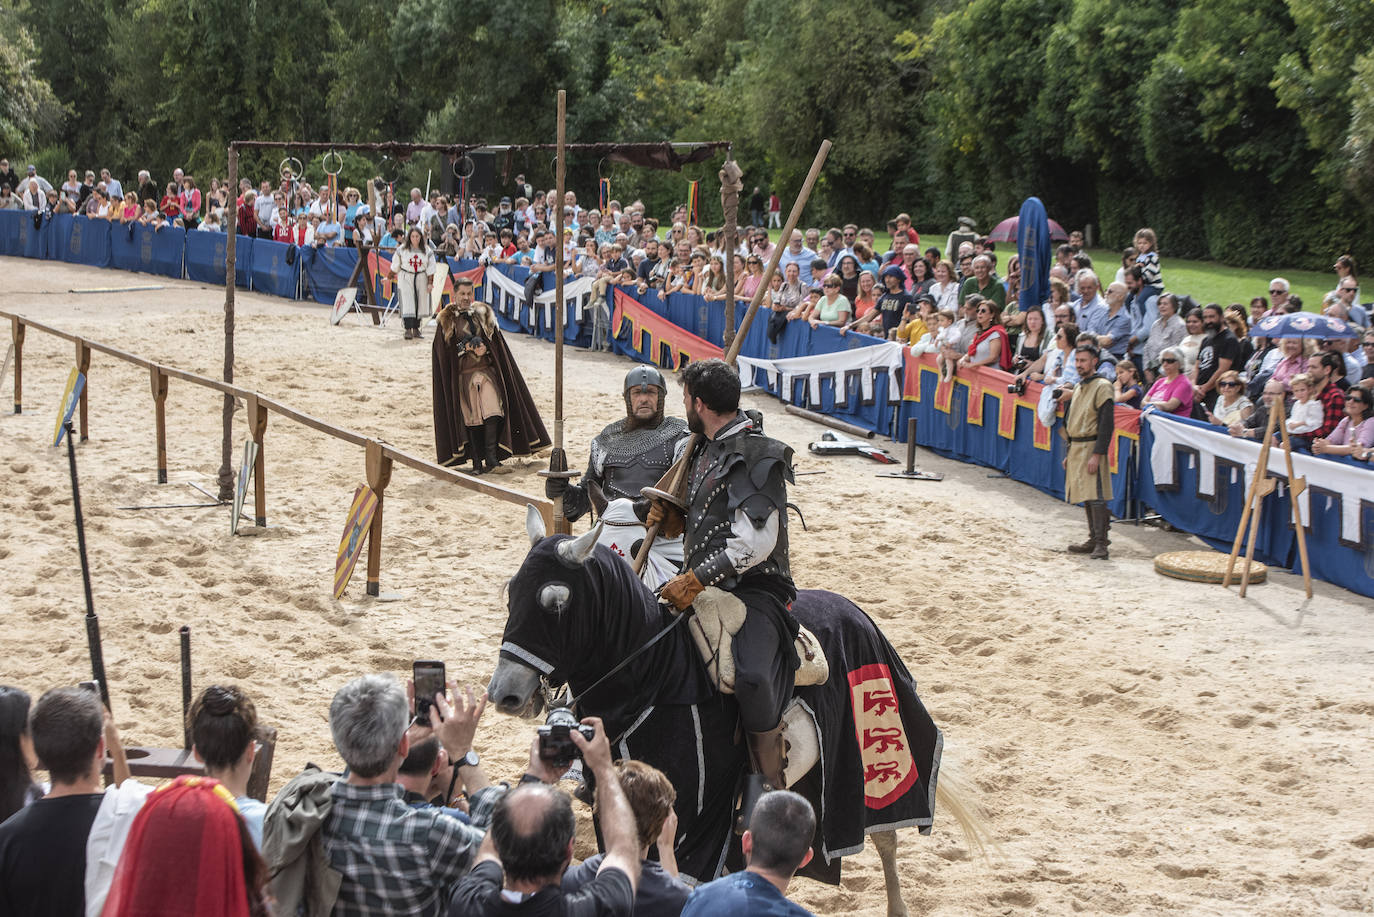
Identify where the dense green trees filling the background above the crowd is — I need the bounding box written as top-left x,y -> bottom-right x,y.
10,0 -> 1374,268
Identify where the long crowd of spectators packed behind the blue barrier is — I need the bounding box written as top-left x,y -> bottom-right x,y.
0,159 -> 1374,459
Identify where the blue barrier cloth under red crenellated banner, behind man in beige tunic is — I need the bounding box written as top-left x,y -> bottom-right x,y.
897,363 -> 1136,517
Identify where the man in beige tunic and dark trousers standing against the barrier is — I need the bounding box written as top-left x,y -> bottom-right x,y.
1063,342 -> 1116,561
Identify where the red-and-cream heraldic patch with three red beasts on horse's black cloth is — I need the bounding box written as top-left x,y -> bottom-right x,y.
849,663 -> 921,808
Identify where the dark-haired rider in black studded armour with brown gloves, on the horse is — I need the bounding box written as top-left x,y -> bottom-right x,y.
649,360 -> 798,789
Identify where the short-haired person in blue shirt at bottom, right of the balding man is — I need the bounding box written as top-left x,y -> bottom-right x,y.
683,791 -> 816,917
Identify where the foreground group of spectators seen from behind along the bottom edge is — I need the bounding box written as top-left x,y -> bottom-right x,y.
0,675 -> 816,917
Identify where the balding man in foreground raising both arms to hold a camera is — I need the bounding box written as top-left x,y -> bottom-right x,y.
448,716 -> 640,917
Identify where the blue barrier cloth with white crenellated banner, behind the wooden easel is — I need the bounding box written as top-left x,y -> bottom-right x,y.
1136,409 -> 1374,597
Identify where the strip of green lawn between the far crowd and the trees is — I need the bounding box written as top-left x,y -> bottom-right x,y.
741,227 -> 1341,312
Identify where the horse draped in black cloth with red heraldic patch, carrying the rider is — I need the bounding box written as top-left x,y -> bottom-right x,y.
488,509 -> 941,914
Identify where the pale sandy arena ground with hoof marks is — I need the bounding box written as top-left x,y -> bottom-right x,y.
0,258 -> 1374,914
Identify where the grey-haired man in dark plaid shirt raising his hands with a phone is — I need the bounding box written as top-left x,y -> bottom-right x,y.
320,675 -> 502,917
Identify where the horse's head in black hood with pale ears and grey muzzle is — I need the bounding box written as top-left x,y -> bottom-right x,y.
486,507 -> 651,716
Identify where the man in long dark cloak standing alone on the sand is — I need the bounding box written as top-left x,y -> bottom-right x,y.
433,278 -> 550,474
